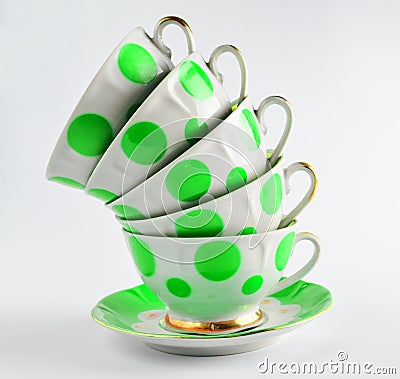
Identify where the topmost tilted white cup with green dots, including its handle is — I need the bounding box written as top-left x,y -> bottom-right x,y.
46,16 -> 195,189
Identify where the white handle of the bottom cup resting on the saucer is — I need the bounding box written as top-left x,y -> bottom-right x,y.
271,232 -> 321,293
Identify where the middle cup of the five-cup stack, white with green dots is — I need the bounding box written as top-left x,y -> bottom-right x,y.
108,96 -> 292,219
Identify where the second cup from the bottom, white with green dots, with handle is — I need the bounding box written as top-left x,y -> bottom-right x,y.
116,159 -> 318,237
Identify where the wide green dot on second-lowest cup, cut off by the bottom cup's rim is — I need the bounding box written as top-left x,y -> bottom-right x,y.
175,209 -> 224,237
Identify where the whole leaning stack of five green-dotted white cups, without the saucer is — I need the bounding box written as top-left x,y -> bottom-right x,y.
47,17 -> 320,335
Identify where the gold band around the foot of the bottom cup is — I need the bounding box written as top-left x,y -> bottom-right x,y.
164,309 -> 264,333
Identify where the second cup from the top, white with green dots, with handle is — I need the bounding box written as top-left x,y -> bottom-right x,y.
86,45 -> 247,202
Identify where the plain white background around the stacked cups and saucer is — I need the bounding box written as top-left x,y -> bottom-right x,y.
0,0 -> 400,379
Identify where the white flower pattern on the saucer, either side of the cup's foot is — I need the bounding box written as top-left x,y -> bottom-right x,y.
131,297 -> 301,334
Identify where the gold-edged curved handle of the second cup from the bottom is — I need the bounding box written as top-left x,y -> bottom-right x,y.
278,162 -> 318,229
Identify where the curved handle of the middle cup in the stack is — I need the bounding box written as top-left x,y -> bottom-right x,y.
256,96 -> 293,166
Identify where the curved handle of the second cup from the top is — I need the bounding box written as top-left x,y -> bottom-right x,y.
208,45 -> 247,104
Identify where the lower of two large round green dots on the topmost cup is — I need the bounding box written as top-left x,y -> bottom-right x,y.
67,113 -> 113,157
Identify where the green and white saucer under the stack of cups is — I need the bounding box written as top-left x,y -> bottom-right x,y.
92,280 -> 333,356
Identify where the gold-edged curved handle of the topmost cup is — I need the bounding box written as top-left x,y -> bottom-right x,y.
153,16 -> 196,59
